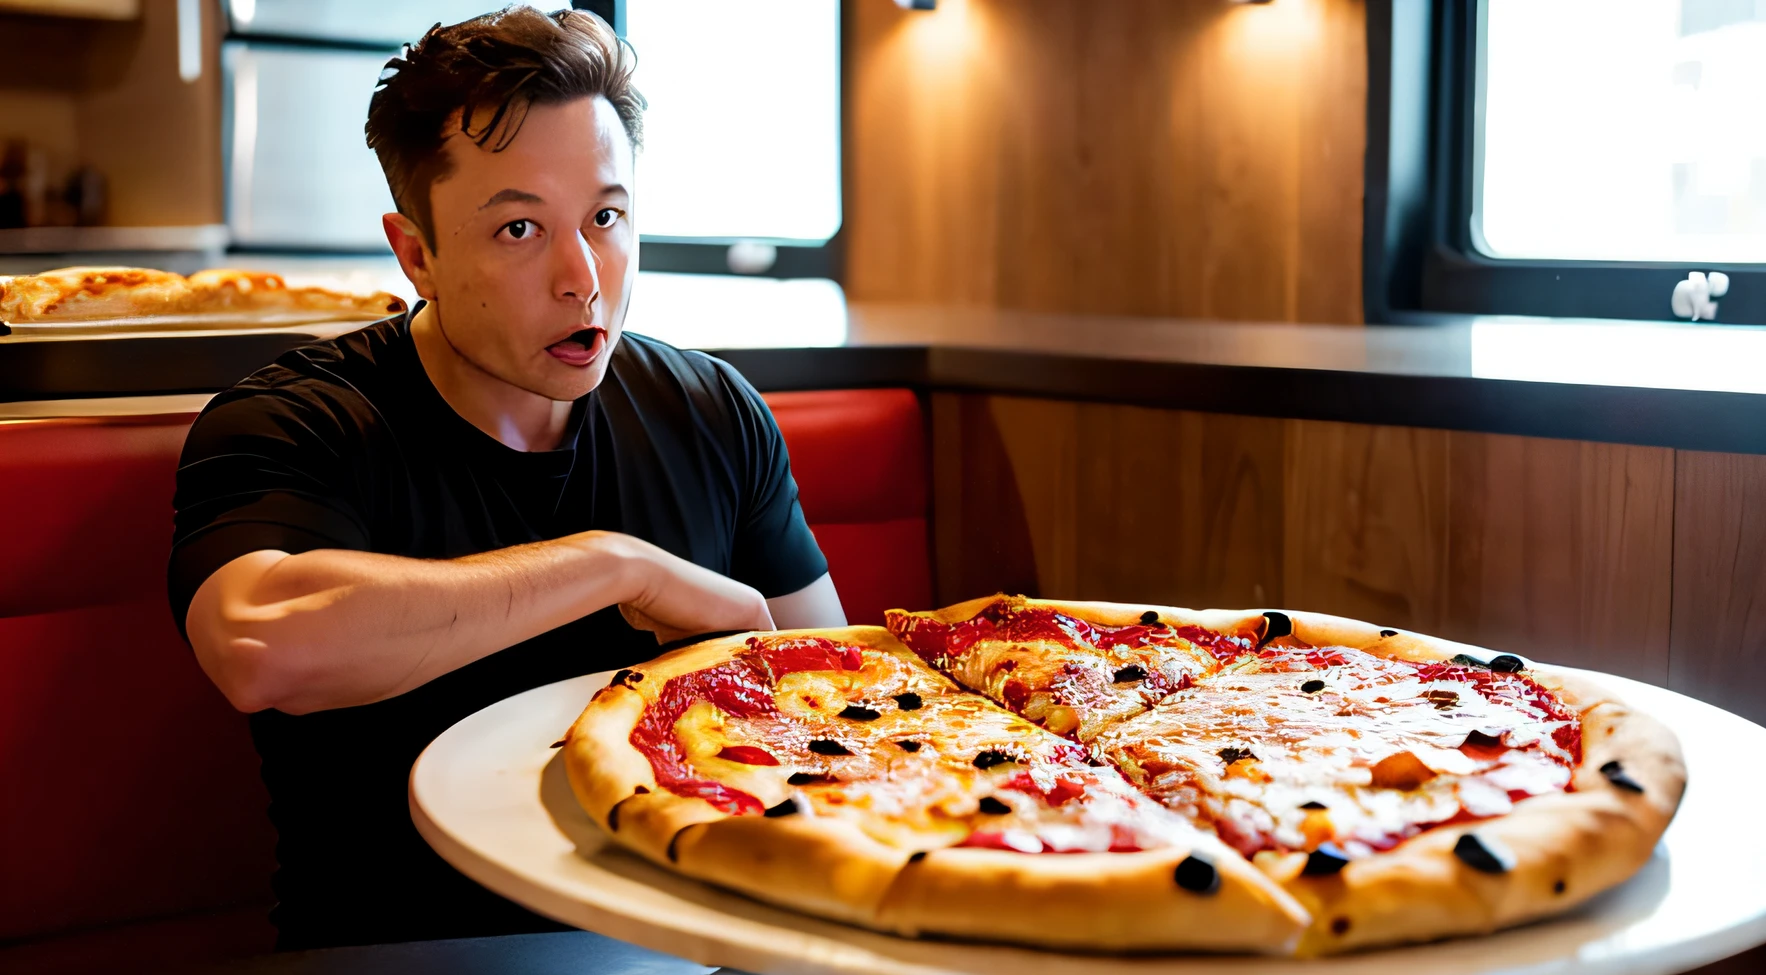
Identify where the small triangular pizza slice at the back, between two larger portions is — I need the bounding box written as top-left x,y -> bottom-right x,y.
885,595 -> 1264,742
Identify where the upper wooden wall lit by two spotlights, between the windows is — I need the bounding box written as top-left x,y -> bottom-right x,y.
846,0 -> 1367,321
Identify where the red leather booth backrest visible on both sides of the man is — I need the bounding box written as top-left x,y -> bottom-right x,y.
0,390 -> 931,971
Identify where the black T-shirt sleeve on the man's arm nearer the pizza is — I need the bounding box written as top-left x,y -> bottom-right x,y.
719,362 -> 828,599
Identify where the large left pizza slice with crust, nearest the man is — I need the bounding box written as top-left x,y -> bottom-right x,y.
565,627 -> 1307,952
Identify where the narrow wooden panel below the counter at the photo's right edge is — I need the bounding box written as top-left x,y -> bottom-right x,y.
1667,450 -> 1766,724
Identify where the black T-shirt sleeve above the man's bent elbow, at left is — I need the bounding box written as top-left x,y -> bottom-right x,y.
166,389 -> 369,632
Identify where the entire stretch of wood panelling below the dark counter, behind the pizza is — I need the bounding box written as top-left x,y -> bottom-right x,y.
932,392 -> 1744,719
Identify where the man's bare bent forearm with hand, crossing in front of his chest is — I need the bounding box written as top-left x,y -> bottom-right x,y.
185,532 -> 773,714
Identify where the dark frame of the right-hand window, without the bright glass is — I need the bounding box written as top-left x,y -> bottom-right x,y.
1362,0 -> 1766,325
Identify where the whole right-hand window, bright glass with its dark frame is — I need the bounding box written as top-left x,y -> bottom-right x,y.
1365,0 -> 1766,323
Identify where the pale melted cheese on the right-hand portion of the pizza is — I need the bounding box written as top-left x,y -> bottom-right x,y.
1093,652 -> 1572,855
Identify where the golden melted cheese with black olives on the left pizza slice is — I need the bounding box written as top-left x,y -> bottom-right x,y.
675,650 -> 1199,851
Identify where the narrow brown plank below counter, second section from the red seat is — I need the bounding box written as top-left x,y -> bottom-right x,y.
1284,420 -> 1448,632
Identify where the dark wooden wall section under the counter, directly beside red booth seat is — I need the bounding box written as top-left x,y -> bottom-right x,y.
932,394 -> 1282,606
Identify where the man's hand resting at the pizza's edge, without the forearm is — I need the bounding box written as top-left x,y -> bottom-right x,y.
620,537 -> 774,643
